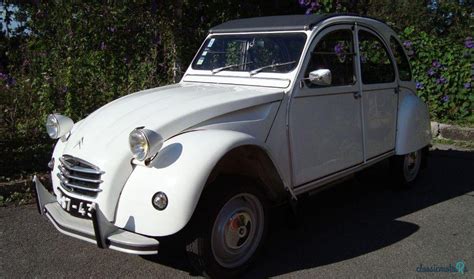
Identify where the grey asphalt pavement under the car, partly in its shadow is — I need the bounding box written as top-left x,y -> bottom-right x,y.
0,150 -> 474,278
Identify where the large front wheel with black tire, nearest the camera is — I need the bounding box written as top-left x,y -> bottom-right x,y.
186,179 -> 269,278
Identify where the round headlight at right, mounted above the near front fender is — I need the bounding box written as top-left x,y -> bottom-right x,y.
128,128 -> 163,161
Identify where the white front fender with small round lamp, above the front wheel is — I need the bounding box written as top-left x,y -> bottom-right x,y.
115,130 -> 263,236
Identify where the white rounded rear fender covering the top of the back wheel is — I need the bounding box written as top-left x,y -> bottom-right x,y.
395,94 -> 431,155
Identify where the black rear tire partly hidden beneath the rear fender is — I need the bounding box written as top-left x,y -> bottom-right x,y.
390,148 -> 426,188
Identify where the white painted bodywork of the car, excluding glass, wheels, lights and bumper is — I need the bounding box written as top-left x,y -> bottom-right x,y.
47,16 -> 431,240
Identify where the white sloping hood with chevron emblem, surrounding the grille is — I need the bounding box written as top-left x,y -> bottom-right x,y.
52,83 -> 284,220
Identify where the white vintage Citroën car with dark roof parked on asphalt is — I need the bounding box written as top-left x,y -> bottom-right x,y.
34,15 -> 431,277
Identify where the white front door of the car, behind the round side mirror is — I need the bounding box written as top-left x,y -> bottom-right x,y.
289,25 -> 363,187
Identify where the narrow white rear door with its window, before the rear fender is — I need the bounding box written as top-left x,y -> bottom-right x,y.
356,26 -> 398,160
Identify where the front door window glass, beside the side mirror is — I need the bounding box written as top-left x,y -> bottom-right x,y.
305,30 -> 356,87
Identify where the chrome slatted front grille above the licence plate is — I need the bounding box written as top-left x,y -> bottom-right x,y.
58,155 -> 104,197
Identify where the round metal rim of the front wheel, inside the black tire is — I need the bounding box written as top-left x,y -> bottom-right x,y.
211,193 -> 265,268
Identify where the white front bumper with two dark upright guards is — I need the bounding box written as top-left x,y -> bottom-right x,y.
33,175 -> 159,255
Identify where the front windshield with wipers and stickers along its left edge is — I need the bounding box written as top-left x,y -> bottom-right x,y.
192,33 -> 306,75
